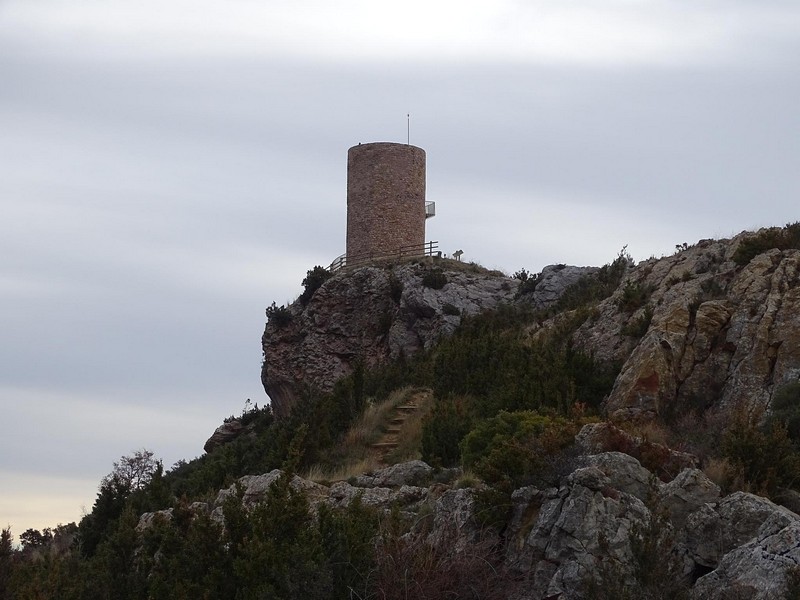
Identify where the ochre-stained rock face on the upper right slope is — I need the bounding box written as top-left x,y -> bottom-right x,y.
575,234 -> 800,420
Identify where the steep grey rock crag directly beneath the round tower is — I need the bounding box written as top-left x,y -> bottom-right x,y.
261,261 -> 519,417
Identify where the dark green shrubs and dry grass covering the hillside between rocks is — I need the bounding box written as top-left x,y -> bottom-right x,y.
0,224 -> 800,599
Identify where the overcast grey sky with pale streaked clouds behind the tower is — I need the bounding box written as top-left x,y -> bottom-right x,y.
0,0 -> 800,534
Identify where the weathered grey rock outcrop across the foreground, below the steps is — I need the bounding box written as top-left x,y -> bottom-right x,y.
145,424 -> 800,600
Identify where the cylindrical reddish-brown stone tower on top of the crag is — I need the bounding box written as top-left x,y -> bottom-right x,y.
347,142 -> 425,263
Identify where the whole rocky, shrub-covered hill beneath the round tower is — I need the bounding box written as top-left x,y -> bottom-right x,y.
0,224 -> 800,600
